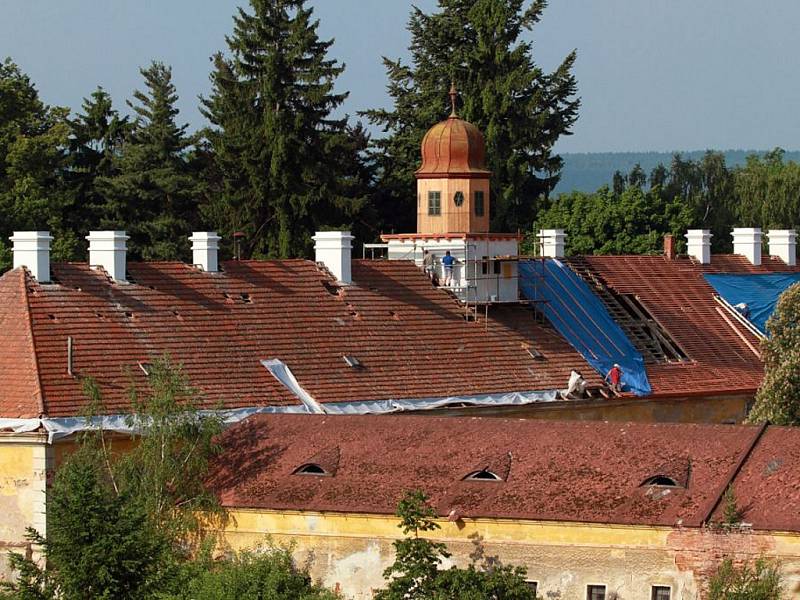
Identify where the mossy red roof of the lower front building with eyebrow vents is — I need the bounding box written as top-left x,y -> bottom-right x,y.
209,415 -> 800,530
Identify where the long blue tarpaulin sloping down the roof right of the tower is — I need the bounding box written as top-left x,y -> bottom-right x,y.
519,258 -> 651,396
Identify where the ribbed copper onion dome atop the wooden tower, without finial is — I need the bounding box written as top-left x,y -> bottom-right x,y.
416,113 -> 490,179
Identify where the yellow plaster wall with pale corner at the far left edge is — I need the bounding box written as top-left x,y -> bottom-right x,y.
0,433 -> 52,580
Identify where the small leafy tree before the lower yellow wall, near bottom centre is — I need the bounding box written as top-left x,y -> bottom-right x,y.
375,490 -> 536,600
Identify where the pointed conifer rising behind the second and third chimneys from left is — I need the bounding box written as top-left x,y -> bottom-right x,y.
97,62 -> 200,260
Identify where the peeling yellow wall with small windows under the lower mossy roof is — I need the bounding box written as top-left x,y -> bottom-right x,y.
219,509 -> 800,600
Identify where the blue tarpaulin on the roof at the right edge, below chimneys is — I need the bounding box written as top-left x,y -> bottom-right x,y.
703,273 -> 800,334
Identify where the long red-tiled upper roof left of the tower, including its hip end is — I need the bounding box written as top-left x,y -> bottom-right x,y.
0,260 -> 599,417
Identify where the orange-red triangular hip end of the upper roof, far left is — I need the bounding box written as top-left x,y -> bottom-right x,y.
0,270 -> 43,418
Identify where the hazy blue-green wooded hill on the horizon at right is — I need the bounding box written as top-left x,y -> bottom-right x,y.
555,150 -> 800,194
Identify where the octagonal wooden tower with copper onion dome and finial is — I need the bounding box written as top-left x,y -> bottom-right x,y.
415,85 -> 491,234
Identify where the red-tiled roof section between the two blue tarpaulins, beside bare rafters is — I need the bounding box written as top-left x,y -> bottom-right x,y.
570,255 -> 798,396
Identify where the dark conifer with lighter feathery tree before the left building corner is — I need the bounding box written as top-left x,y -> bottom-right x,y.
0,359 -> 224,600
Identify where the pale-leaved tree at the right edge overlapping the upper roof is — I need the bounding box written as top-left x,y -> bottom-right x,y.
748,284 -> 800,425
